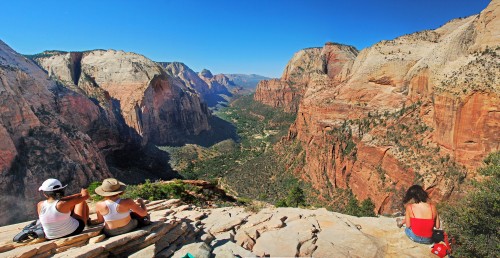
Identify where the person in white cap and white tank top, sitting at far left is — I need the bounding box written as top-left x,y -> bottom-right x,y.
37,178 -> 89,239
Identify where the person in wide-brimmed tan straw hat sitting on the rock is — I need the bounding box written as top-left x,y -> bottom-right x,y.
95,178 -> 148,236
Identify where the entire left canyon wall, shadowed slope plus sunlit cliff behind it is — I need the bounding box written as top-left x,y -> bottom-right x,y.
0,41 -> 221,224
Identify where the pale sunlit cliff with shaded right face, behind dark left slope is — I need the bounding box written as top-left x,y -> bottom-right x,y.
36,50 -> 209,144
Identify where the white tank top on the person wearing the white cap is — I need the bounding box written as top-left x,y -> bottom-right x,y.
40,200 -> 79,239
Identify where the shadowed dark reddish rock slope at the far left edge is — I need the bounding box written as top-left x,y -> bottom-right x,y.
0,41 -> 113,224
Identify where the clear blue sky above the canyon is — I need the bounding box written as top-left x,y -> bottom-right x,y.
0,0 -> 489,77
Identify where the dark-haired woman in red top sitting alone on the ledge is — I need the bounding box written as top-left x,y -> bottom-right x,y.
396,185 -> 440,244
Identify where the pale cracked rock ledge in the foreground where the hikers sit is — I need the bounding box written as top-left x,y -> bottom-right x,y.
0,200 -> 432,258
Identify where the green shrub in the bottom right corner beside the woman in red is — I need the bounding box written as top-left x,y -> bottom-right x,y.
441,152 -> 500,257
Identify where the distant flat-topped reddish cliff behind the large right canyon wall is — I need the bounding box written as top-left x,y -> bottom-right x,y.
254,43 -> 358,113
